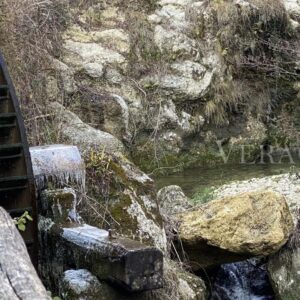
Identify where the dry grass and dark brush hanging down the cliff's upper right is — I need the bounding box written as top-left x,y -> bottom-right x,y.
204,0 -> 297,125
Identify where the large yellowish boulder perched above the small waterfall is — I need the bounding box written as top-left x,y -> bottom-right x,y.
179,190 -> 294,269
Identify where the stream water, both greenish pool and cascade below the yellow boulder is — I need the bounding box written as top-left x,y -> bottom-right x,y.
156,160 -> 300,300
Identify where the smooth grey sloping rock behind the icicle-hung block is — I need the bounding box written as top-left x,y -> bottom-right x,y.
50,102 -> 125,153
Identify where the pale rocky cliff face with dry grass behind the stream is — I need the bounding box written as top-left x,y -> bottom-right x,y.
3,0 -> 300,171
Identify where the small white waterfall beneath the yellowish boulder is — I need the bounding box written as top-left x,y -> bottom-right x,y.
210,259 -> 275,300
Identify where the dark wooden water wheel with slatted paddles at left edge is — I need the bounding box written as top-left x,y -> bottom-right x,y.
0,54 -> 38,266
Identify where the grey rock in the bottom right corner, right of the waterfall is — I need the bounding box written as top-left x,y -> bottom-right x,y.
268,221 -> 300,300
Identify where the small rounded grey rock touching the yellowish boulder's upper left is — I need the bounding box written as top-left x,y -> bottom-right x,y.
157,185 -> 192,216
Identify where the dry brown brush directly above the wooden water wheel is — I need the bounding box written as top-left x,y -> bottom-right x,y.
0,0 -> 67,145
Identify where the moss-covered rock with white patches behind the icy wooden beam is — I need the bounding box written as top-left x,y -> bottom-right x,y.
83,152 -> 166,251
